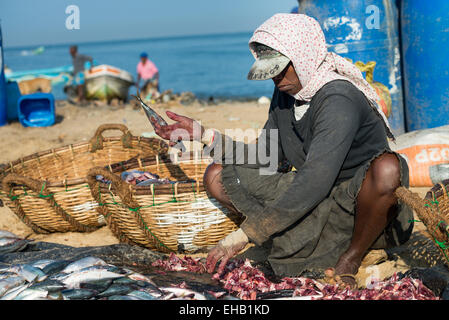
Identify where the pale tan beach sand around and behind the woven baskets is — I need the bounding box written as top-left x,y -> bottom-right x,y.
0,100 -> 269,247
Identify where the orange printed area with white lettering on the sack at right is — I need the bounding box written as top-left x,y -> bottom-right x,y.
397,144 -> 449,187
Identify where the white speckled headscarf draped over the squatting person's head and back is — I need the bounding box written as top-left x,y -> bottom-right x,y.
249,14 -> 393,138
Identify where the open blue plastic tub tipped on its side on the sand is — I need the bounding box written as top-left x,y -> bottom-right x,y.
17,93 -> 55,127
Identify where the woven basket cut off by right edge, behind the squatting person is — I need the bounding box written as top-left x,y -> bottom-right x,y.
396,180 -> 449,266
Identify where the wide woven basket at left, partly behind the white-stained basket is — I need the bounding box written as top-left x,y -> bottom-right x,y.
0,124 -> 168,233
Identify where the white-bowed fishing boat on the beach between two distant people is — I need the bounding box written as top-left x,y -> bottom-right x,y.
85,64 -> 134,101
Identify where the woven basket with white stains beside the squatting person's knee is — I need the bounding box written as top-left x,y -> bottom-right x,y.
88,155 -> 240,252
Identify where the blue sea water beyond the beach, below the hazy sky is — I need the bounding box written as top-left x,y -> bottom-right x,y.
4,33 -> 274,99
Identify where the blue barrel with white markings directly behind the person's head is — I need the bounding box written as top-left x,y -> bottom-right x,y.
298,0 -> 405,134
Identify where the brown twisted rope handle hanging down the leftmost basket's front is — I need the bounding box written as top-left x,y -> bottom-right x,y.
2,173 -> 97,233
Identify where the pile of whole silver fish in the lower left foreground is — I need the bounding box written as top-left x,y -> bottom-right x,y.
0,231 -> 232,300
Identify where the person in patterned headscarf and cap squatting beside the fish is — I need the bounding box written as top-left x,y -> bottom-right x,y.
151,14 -> 413,287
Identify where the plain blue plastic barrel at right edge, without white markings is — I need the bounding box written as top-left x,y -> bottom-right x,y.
401,0 -> 449,131
